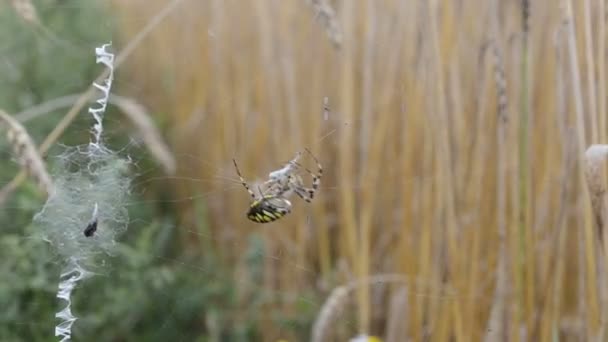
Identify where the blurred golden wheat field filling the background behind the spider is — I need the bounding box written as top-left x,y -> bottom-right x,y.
101,0 -> 608,341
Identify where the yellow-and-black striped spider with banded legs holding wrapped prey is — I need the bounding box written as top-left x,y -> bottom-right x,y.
232,149 -> 323,223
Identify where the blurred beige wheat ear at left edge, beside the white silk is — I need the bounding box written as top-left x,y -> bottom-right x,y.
0,110 -> 53,197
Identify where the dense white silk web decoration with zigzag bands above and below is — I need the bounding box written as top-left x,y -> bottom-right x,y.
34,44 -> 131,341
